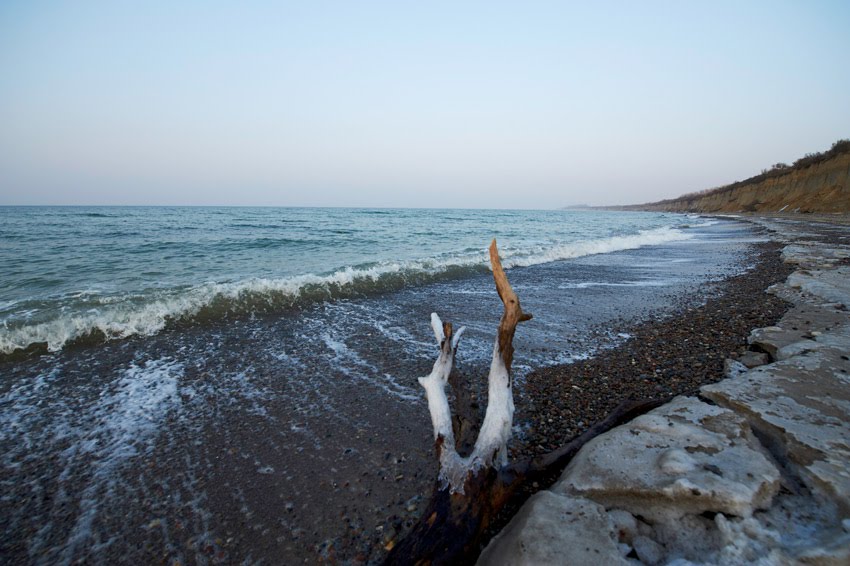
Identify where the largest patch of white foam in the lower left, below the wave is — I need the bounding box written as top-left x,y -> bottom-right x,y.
0,358 -> 183,564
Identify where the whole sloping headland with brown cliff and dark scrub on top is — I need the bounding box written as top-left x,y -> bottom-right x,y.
605,139 -> 850,213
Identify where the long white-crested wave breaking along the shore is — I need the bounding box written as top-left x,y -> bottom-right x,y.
0,228 -> 692,355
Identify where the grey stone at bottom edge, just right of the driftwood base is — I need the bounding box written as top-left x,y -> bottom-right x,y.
478,491 -> 629,566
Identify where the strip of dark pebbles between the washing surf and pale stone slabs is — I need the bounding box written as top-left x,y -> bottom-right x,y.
470,234 -> 793,556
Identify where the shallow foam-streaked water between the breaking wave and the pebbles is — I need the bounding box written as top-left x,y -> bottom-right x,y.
0,211 -> 757,564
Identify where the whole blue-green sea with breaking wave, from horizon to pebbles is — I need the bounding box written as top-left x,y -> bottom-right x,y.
0,207 -> 763,564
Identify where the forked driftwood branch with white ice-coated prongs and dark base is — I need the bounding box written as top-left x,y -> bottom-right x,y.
386,240 -> 664,565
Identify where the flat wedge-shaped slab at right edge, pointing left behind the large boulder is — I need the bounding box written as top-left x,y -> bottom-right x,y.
701,325 -> 850,514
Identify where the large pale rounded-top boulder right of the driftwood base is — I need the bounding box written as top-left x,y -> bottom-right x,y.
552,397 -> 780,520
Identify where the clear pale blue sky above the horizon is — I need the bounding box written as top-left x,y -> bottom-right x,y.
0,0 -> 850,208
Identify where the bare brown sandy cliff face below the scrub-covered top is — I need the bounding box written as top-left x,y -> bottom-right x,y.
634,153 -> 850,213
